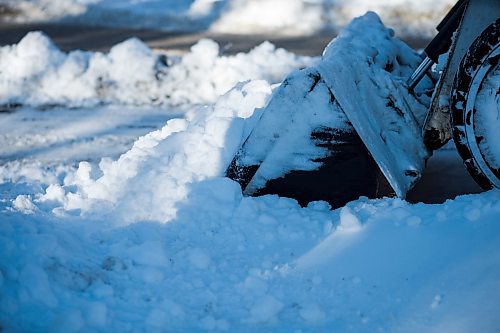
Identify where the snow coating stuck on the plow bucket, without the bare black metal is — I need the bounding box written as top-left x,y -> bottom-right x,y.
232,13 -> 432,197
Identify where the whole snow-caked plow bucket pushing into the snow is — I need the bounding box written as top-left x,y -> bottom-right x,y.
226,13 -> 432,207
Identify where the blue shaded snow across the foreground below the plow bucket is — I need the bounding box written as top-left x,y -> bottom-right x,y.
0,183 -> 500,332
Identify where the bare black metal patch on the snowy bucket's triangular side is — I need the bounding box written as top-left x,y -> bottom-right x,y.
254,129 -> 381,208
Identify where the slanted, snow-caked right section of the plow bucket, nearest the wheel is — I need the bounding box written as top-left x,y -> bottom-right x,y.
317,13 -> 429,197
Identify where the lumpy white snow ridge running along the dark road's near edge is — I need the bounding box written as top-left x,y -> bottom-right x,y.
0,32 -> 314,107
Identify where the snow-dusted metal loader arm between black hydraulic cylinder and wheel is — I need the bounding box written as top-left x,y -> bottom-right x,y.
423,0 -> 500,150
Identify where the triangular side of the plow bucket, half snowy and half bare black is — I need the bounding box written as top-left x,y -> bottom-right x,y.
226,68 -> 386,207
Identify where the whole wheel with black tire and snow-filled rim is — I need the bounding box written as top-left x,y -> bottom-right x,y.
451,19 -> 500,189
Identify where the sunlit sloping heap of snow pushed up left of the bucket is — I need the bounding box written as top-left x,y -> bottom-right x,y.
36,81 -> 271,222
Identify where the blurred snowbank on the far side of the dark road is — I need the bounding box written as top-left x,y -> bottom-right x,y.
0,0 -> 455,36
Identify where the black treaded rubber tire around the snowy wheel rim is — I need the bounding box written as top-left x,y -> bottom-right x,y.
451,19 -> 500,190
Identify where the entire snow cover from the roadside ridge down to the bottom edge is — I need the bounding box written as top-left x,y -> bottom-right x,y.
0,9 -> 500,332
